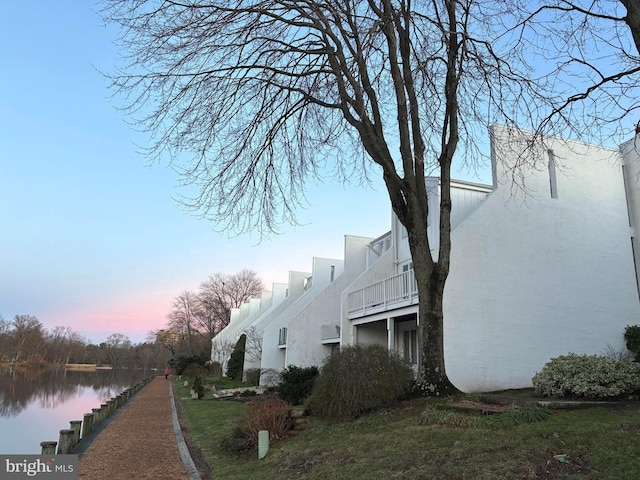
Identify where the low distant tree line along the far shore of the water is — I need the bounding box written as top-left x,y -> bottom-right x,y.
0,315 -> 171,369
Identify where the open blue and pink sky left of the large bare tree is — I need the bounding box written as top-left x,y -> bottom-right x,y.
0,0 -> 490,343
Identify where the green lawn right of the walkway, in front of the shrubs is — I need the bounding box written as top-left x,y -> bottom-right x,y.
174,382 -> 640,480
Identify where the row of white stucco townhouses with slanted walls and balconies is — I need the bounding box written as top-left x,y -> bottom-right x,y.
214,126 -> 640,392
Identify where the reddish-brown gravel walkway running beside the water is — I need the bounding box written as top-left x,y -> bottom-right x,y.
78,377 -> 200,480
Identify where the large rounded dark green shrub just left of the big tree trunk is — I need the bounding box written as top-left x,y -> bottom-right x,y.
307,345 -> 413,420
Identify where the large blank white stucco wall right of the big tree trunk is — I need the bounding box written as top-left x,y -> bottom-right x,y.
445,128 -> 640,391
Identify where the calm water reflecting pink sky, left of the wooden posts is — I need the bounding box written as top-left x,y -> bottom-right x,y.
0,368 -> 150,455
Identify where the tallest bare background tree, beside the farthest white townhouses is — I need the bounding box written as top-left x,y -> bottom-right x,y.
198,269 -> 263,339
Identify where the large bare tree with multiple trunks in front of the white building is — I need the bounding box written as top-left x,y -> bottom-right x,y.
102,0 -> 568,395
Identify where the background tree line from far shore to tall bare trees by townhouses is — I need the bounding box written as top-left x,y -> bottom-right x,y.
0,269 -> 263,368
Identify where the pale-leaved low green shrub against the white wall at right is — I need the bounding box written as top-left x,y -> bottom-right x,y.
533,353 -> 640,399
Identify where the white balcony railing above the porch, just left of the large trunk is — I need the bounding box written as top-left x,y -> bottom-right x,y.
347,270 -> 418,315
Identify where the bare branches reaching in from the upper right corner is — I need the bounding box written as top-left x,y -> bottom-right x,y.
505,0 -> 640,142
